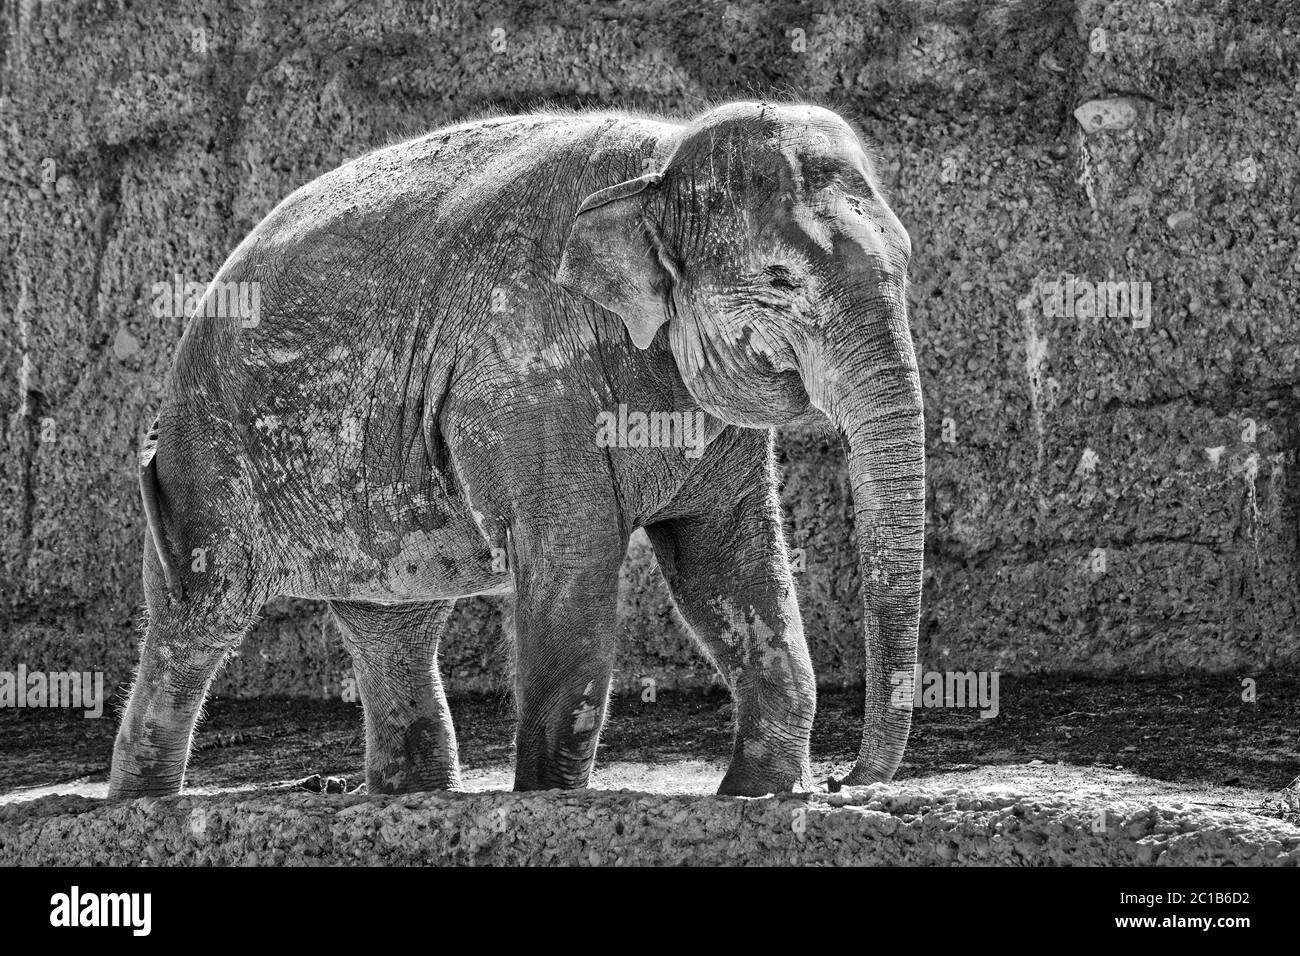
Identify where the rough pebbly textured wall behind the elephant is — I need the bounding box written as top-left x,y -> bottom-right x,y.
0,0 -> 1300,695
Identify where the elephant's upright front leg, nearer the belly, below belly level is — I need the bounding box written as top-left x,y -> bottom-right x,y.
514,536 -> 627,791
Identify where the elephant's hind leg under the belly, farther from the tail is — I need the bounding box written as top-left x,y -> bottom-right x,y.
330,601 -> 460,793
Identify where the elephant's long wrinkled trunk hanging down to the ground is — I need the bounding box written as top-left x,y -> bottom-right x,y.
822,300 -> 926,784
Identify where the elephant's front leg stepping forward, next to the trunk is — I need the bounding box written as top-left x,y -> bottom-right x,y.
646,489 -> 816,796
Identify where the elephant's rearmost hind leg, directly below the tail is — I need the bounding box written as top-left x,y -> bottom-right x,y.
108,546 -> 257,800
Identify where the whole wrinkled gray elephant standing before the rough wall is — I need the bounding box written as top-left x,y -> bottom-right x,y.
111,103 -> 924,797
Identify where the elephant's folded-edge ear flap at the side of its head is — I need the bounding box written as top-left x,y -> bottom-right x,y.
555,174 -> 677,349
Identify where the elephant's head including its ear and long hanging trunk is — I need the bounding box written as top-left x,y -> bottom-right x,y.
556,103 -> 924,783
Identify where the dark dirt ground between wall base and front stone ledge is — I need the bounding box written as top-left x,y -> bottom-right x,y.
0,674 -> 1300,823
